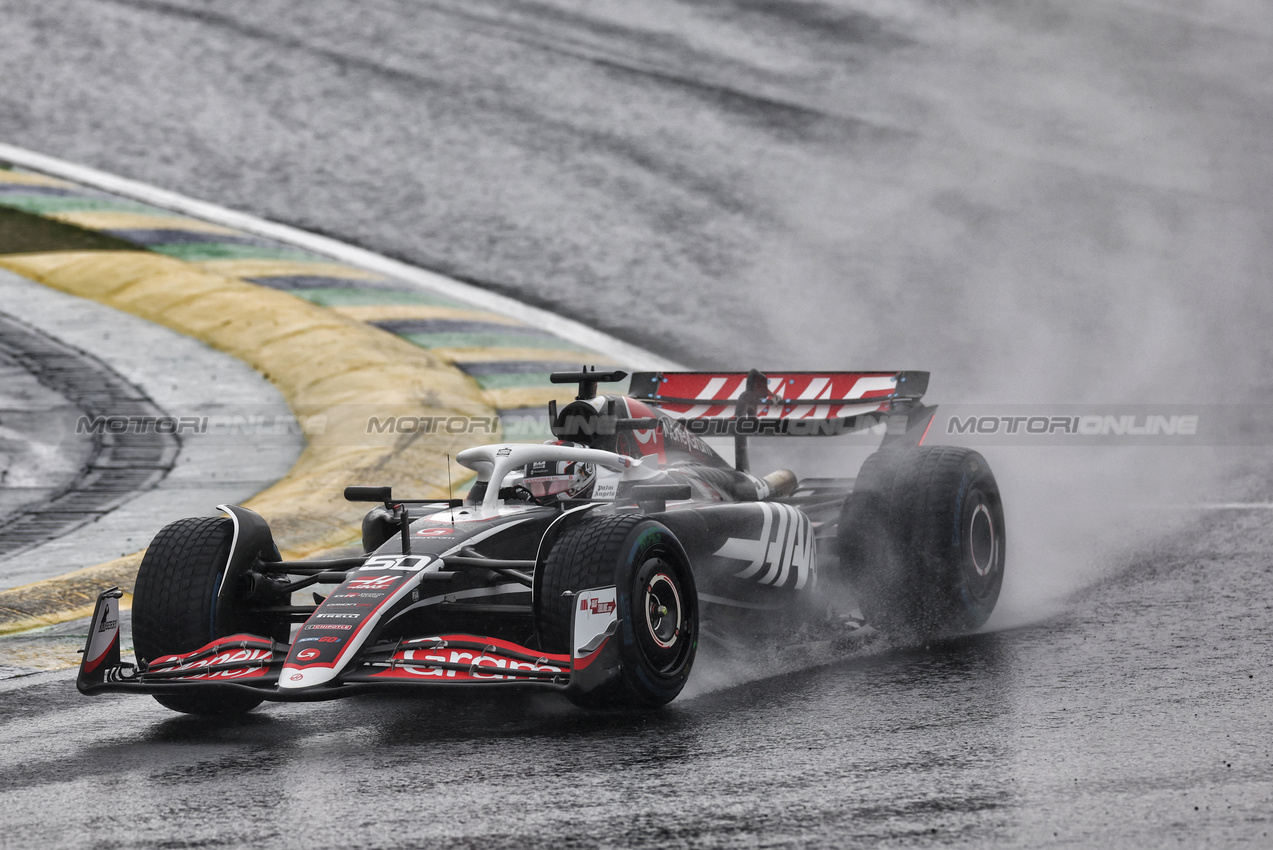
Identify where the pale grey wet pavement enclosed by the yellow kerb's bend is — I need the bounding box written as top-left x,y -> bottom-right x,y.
0,270 -> 302,588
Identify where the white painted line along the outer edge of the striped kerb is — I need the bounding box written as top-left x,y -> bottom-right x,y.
0,143 -> 685,370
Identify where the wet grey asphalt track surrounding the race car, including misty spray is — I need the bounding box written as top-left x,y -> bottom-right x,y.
0,0 -> 1273,847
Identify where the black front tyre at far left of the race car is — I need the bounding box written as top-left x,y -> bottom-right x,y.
132,517 -> 261,714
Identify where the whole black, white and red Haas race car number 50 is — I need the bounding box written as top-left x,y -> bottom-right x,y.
78,370 -> 1004,714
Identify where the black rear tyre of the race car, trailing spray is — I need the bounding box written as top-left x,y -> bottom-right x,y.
839,445 -> 1006,639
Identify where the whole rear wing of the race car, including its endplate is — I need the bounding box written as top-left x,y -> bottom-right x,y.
628,369 -> 936,471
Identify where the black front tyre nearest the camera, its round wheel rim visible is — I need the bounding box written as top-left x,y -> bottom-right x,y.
535,515 -> 699,709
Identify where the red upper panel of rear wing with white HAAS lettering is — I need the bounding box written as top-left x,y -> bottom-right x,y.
628,372 -> 928,419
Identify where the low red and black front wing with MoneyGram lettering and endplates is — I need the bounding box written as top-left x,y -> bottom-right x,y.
76,588 -> 620,702
